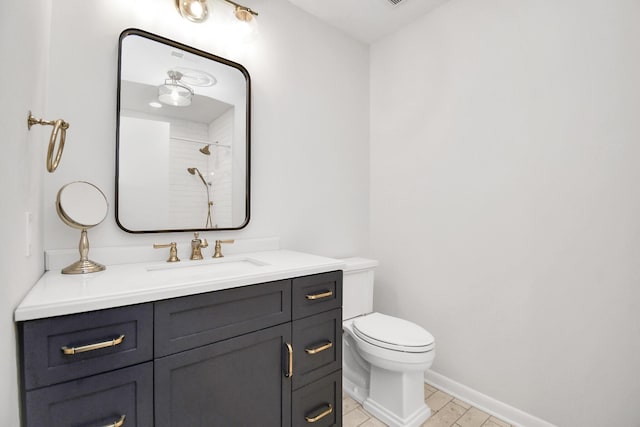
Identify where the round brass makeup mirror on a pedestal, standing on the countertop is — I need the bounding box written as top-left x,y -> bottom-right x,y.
56,181 -> 109,274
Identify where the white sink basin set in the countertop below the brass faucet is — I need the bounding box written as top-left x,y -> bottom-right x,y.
147,257 -> 268,281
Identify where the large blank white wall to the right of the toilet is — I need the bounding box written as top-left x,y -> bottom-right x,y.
370,0 -> 640,427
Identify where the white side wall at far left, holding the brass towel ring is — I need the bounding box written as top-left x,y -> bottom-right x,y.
0,1 -> 51,426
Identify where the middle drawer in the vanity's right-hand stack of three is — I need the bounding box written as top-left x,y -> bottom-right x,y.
292,308 -> 342,389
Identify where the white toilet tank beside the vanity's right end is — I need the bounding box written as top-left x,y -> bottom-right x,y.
342,258 -> 378,320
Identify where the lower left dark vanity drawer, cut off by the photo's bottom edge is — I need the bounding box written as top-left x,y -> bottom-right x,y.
23,362 -> 153,427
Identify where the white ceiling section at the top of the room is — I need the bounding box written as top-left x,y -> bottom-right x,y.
289,0 -> 447,43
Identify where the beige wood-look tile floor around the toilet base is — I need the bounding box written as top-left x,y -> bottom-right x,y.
342,384 -> 511,427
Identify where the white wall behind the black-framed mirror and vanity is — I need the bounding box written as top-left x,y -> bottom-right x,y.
44,0 -> 369,261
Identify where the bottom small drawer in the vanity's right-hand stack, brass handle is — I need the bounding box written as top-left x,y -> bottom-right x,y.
291,371 -> 342,427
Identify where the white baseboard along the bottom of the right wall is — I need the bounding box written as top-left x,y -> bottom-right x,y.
424,370 -> 557,427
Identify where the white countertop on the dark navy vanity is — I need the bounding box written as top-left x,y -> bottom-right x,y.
14,250 -> 345,321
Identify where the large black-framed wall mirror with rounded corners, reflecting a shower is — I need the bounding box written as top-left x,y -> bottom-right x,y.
115,29 -> 251,233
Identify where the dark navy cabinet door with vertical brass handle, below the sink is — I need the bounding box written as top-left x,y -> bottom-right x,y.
154,324 -> 291,427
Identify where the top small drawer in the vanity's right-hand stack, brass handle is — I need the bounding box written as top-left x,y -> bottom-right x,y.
293,270 -> 342,319
